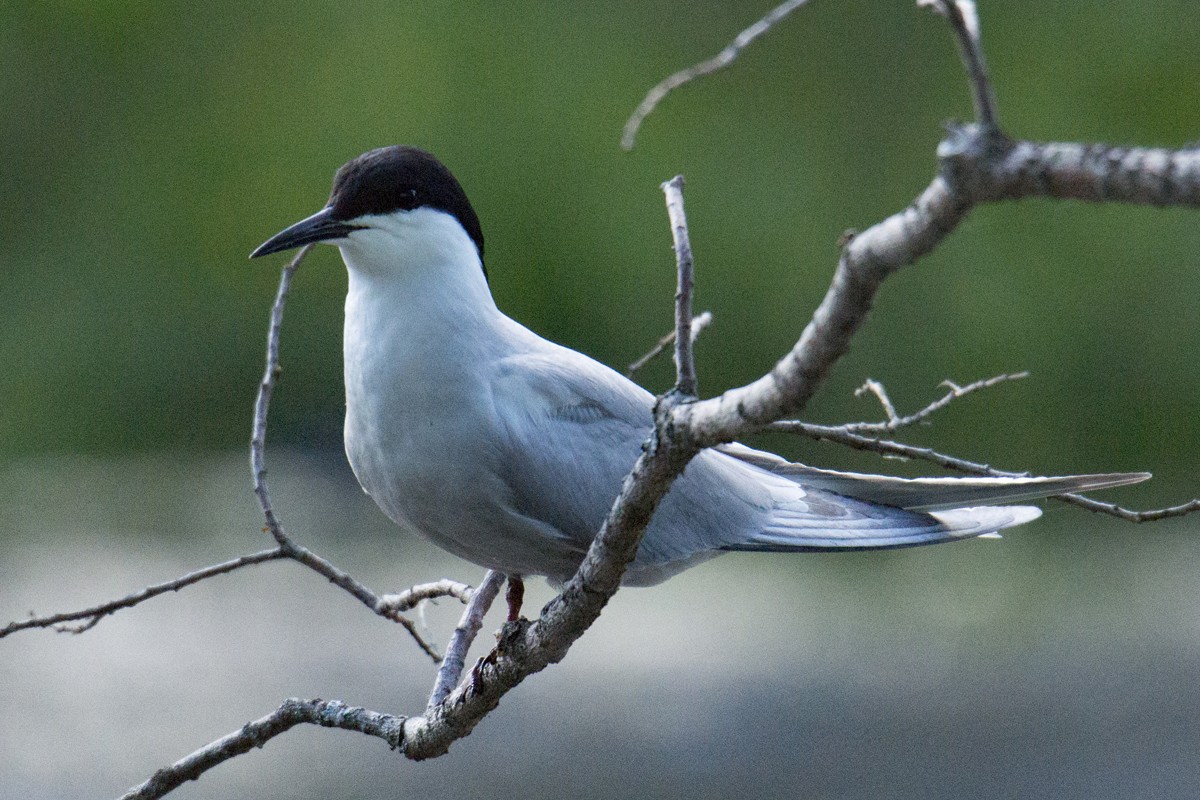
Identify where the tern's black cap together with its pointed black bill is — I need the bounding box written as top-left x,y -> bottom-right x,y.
251,145 -> 484,261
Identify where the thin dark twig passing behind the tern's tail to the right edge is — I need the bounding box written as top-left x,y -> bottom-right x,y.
767,420 -> 1200,522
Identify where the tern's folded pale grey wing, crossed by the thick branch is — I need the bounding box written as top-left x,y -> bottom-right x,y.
493,347 -> 1039,583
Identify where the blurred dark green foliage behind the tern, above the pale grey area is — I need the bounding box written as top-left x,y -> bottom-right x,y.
0,0 -> 1200,500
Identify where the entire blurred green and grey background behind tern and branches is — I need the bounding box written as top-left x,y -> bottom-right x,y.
0,0 -> 1200,800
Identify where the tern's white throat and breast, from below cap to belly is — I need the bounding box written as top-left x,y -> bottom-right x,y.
333,209 -> 566,571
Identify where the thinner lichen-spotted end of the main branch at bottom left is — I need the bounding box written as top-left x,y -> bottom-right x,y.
121,698 -> 404,800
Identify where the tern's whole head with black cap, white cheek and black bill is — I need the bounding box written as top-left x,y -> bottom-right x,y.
250,145 -> 486,280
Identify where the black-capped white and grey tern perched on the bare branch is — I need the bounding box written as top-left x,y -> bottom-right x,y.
251,145 -> 1150,597
